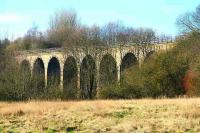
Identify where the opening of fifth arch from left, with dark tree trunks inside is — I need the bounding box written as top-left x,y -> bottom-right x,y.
80,55 -> 96,99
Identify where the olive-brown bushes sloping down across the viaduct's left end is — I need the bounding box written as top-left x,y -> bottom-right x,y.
0,47 -> 61,101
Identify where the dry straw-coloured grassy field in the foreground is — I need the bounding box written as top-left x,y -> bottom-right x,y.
0,98 -> 200,133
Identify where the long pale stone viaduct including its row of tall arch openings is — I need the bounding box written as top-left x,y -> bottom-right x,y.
16,43 -> 175,99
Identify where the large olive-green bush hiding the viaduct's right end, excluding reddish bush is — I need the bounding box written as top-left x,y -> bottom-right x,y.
99,44 -> 189,98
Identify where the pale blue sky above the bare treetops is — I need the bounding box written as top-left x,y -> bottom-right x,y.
0,0 -> 200,39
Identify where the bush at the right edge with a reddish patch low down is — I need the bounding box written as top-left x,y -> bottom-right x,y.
179,32 -> 200,96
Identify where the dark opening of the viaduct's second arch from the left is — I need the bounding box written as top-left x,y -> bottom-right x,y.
32,58 -> 45,93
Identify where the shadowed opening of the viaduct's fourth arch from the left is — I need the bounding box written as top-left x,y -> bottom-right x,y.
63,57 -> 78,99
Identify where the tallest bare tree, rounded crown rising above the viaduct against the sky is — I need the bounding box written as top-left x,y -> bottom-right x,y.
47,10 -> 79,47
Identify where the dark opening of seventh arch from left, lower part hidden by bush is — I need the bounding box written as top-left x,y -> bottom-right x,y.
121,53 -> 138,71
